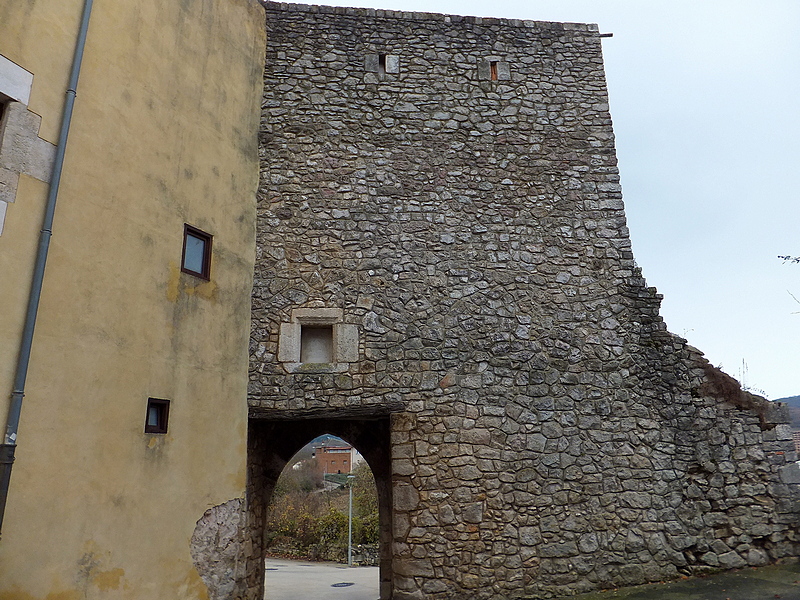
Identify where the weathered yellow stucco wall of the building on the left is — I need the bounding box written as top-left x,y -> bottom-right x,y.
0,0 -> 265,600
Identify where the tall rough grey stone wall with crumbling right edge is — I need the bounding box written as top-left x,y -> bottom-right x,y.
249,3 -> 800,599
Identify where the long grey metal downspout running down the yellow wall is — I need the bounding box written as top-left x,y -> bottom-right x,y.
0,0 -> 92,531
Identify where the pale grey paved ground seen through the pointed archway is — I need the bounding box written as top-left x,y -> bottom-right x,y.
264,558 -> 379,600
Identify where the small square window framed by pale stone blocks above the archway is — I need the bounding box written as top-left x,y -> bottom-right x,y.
278,308 -> 358,373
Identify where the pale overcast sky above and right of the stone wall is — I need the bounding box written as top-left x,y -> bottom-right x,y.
284,0 -> 800,400
